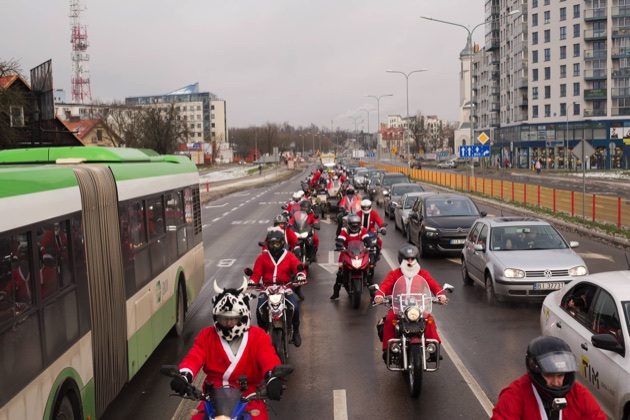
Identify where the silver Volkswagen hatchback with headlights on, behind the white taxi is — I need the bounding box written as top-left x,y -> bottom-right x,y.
462,217 -> 588,303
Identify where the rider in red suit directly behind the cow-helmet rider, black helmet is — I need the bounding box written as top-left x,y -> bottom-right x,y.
250,229 -> 306,347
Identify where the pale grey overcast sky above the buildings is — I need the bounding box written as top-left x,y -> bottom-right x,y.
0,0 -> 484,131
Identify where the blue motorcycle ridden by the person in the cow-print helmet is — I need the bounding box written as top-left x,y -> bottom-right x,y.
160,365 -> 293,420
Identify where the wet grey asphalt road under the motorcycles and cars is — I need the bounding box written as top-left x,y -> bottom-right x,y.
105,171 -> 626,420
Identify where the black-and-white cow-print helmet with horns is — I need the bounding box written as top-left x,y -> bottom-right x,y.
212,279 -> 251,341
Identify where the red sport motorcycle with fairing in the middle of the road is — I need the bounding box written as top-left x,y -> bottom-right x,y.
337,239 -> 374,309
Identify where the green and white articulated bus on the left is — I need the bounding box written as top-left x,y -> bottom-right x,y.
0,147 -> 204,420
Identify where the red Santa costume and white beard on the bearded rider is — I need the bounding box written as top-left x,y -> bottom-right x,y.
376,266 -> 442,350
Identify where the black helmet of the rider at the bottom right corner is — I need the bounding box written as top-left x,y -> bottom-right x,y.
525,336 -> 577,402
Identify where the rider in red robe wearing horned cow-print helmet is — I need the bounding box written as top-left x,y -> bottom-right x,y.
171,281 -> 283,420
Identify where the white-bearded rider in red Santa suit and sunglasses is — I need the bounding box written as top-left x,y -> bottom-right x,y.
374,244 -> 448,360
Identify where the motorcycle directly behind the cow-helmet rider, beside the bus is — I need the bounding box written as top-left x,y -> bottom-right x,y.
244,266 -> 306,363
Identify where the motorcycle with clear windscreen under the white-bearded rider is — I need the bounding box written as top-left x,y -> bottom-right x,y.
371,275 -> 454,398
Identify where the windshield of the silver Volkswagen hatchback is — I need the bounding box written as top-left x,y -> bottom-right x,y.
490,225 -> 569,251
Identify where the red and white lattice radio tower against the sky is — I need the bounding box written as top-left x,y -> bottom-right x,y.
70,0 -> 92,104
